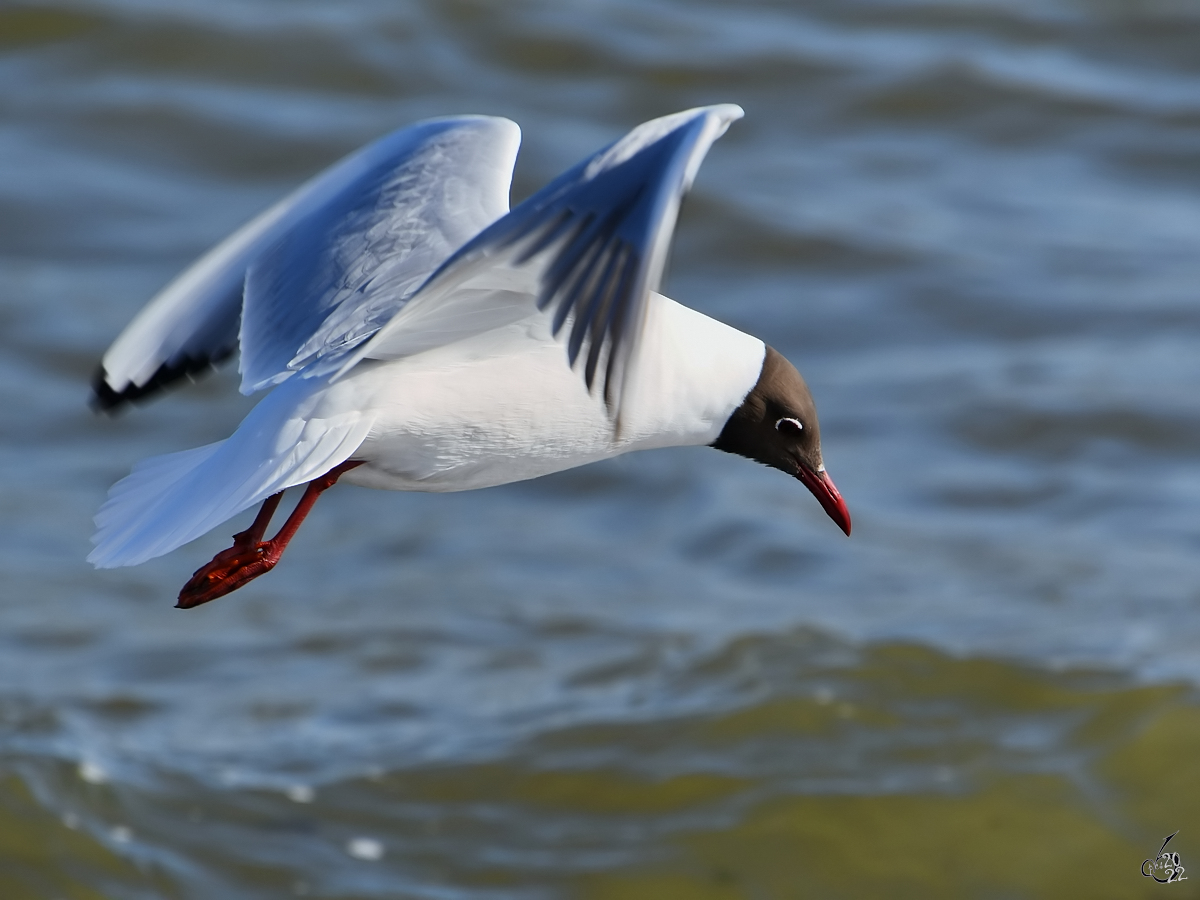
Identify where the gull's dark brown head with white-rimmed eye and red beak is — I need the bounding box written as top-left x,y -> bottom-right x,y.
713,347 -> 850,535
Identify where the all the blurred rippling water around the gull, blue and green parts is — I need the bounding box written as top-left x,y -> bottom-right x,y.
0,0 -> 1200,900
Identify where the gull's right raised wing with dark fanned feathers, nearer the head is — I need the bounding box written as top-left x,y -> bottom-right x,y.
338,104 -> 743,418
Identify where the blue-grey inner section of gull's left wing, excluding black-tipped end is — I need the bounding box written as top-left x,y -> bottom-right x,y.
241,116 -> 520,392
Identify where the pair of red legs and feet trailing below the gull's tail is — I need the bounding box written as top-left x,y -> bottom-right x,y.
175,460 -> 362,610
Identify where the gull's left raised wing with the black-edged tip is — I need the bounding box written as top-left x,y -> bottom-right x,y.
92,116 -> 521,408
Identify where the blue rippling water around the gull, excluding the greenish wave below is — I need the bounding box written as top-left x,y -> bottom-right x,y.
0,0 -> 1200,896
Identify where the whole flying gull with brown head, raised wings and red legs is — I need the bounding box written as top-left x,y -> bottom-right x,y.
88,104 -> 851,608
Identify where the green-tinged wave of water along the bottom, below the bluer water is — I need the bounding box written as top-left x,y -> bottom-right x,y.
0,637 -> 1200,900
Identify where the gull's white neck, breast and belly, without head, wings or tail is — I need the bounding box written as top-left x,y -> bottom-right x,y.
328,294 -> 766,491
